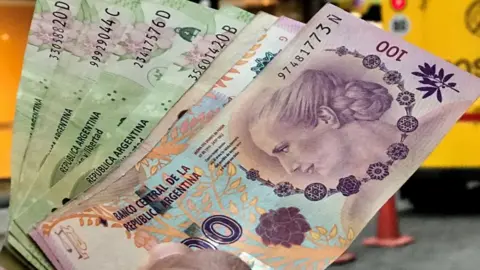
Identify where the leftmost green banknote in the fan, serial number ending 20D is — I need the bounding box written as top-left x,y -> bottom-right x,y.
10,0 -> 79,209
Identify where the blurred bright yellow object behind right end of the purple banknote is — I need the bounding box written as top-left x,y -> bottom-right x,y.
382,0 -> 480,168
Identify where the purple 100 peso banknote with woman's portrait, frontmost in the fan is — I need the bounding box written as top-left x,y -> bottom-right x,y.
32,5 -> 480,269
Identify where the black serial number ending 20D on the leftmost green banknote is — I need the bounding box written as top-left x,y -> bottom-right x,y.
49,1 -> 70,61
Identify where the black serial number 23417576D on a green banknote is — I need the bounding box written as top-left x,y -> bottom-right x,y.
133,10 -> 171,68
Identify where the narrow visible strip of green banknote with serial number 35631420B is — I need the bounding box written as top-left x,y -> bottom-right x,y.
59,4 -> 253,196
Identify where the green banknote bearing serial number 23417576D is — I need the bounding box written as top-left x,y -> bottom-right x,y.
16,0 -> 252,215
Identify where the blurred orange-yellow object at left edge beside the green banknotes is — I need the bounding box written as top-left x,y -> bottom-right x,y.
0,1 -> 35,179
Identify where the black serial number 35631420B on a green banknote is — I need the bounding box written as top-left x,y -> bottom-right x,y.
188,25 -> 238,81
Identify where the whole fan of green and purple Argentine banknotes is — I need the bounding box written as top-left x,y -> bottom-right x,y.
6,0 -> 480,269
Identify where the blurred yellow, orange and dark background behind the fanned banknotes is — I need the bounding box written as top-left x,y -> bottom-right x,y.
0,0 -> 480,270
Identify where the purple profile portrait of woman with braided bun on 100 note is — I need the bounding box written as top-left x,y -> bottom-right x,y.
247,70 -> 398,188
